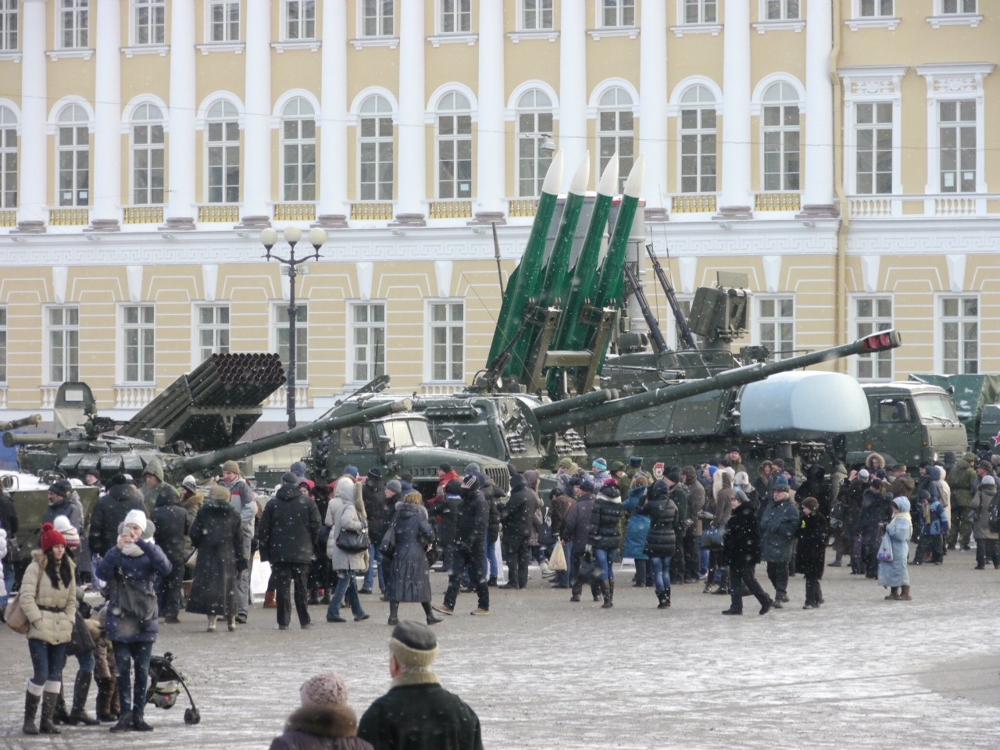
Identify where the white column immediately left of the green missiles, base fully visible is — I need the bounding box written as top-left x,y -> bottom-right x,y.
470,0 -> 507,224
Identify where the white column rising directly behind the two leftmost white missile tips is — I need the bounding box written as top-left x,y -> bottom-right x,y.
557,0 -> 587,178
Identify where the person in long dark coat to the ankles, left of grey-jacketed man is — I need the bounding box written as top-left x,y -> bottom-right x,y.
187,486 -> 247,633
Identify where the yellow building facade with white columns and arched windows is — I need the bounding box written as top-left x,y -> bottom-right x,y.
0,0 -> 1000,422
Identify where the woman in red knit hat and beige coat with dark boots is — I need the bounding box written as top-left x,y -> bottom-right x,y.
20,523 -> 76,734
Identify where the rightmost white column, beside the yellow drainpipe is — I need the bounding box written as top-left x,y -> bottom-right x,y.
802,0 -> 837,217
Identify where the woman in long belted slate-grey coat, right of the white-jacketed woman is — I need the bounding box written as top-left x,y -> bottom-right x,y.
387,492 -> 441,625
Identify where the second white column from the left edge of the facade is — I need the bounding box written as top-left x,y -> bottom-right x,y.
84,0 -> 122,232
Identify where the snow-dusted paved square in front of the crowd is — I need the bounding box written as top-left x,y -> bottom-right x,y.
0,552 -> 1000,750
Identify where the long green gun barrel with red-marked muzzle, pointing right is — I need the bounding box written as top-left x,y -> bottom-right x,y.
536,331 -> 902,435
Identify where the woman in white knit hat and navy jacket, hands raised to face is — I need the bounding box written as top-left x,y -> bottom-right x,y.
97,510 -> 172,732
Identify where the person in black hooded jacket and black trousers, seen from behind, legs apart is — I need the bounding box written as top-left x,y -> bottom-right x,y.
258,472 -> 323,630
